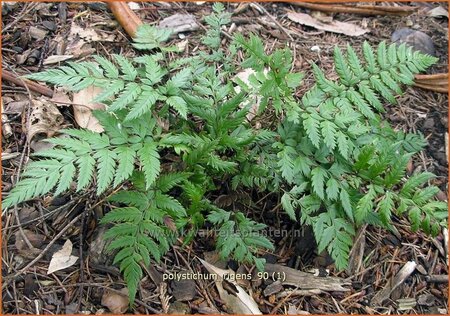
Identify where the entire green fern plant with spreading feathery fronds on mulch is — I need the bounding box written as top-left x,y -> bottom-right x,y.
2,3 -> 447,303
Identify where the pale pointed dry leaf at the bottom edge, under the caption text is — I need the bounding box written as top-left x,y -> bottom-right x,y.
199,259 -> 262,315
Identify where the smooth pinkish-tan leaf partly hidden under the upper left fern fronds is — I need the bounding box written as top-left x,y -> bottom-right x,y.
73,86 -> 105,133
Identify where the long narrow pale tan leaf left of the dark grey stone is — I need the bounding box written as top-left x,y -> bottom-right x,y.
287,11 -> 369,36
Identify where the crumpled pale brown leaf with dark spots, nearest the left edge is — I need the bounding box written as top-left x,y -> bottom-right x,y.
27,97 -> 64,142
